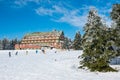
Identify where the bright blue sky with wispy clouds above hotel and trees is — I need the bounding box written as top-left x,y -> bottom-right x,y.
0,0 -> 120,39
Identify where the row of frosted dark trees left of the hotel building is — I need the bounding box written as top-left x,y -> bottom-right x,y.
0,38 -> 20,50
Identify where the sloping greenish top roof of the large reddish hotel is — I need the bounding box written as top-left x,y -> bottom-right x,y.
25,30 -> 63,37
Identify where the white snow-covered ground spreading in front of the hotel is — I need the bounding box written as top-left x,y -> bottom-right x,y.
0,50 -> 120,80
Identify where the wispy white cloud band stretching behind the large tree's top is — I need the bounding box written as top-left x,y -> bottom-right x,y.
36,5 -> 111,27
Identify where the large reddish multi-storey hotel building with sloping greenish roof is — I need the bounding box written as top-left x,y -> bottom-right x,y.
15,30 -> 64,49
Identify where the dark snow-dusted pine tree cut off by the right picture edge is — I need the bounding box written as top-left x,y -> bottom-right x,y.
111,4 -> 120,55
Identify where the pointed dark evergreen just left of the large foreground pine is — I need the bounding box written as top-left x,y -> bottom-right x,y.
73,31 -> 82,50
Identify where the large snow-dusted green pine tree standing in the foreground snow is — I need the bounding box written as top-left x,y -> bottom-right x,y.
80,9 -> 115,72
